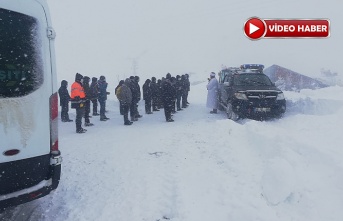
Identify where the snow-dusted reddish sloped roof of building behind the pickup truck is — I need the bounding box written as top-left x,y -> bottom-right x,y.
264,64 -> 329,91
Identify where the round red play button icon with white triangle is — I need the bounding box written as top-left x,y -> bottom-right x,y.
244,17 -> 266,40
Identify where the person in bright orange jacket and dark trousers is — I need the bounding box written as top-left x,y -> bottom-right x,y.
70,73 -> 87,133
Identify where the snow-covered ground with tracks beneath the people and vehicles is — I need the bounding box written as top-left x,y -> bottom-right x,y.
2,83 -> 343,221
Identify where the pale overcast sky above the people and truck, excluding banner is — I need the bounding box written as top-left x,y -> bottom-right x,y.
48,0 -> 343,84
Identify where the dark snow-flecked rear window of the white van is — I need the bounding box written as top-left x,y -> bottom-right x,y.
0,8 -> 43,98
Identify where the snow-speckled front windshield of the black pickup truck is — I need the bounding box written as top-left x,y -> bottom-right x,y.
233,73 -> 272,86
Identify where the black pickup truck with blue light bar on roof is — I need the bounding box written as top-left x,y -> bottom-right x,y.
218,64 -> 286,121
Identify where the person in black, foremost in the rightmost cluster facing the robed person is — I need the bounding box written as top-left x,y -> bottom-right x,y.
162,73 -> 176,122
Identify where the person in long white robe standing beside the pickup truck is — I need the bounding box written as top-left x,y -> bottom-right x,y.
206,72 -> 218,114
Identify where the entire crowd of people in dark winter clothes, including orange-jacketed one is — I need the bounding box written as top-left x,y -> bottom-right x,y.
58,73 -> 190,133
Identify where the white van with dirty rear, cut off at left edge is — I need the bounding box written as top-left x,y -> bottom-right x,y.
0,0 -> 62,210
